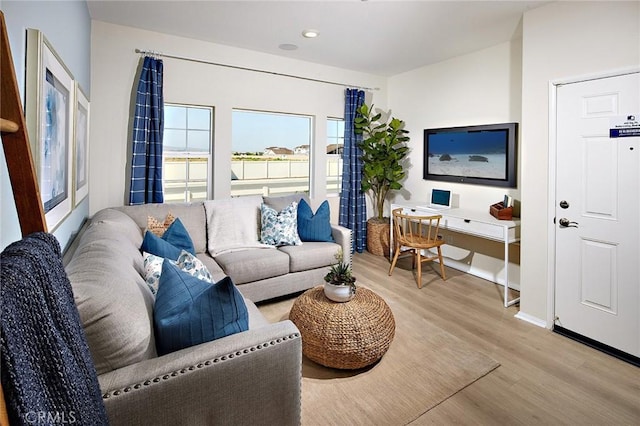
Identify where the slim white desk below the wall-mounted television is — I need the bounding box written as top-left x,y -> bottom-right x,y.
390,201 -> 520,308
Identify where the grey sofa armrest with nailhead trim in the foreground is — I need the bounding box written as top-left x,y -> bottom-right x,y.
98,320 -> 302,426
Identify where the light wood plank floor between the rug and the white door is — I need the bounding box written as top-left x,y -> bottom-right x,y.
353,252 -> 640,425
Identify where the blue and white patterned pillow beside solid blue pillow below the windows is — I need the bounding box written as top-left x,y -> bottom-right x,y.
260,201 -> 302,246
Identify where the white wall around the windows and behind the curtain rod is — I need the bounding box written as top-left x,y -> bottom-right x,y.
89,21 -> 386,217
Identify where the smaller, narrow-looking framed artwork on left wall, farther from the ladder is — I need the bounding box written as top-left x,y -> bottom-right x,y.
73,83 -> 89,206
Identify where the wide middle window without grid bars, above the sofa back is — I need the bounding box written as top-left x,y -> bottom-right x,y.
231,110 -> 312,196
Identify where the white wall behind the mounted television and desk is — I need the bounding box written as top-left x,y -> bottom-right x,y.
389,40 -> 522,287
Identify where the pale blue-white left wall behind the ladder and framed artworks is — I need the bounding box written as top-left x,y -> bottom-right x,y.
0,0 -> 91,249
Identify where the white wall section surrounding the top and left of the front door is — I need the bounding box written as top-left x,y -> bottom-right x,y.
520,2 -> 640,320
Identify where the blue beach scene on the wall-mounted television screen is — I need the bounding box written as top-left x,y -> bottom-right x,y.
427,130 -> 507,180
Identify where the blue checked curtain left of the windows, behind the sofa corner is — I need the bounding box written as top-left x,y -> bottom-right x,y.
129,56 -> 164,205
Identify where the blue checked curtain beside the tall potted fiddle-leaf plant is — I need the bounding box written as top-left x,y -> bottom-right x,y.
338,89 -> 367,253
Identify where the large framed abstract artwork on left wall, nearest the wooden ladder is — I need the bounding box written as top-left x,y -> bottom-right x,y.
25,29 -> 76,232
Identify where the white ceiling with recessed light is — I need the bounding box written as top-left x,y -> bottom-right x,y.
87,0 -> 549,76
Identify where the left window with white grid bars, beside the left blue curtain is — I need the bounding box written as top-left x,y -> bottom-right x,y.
162,104 -> 213,203
